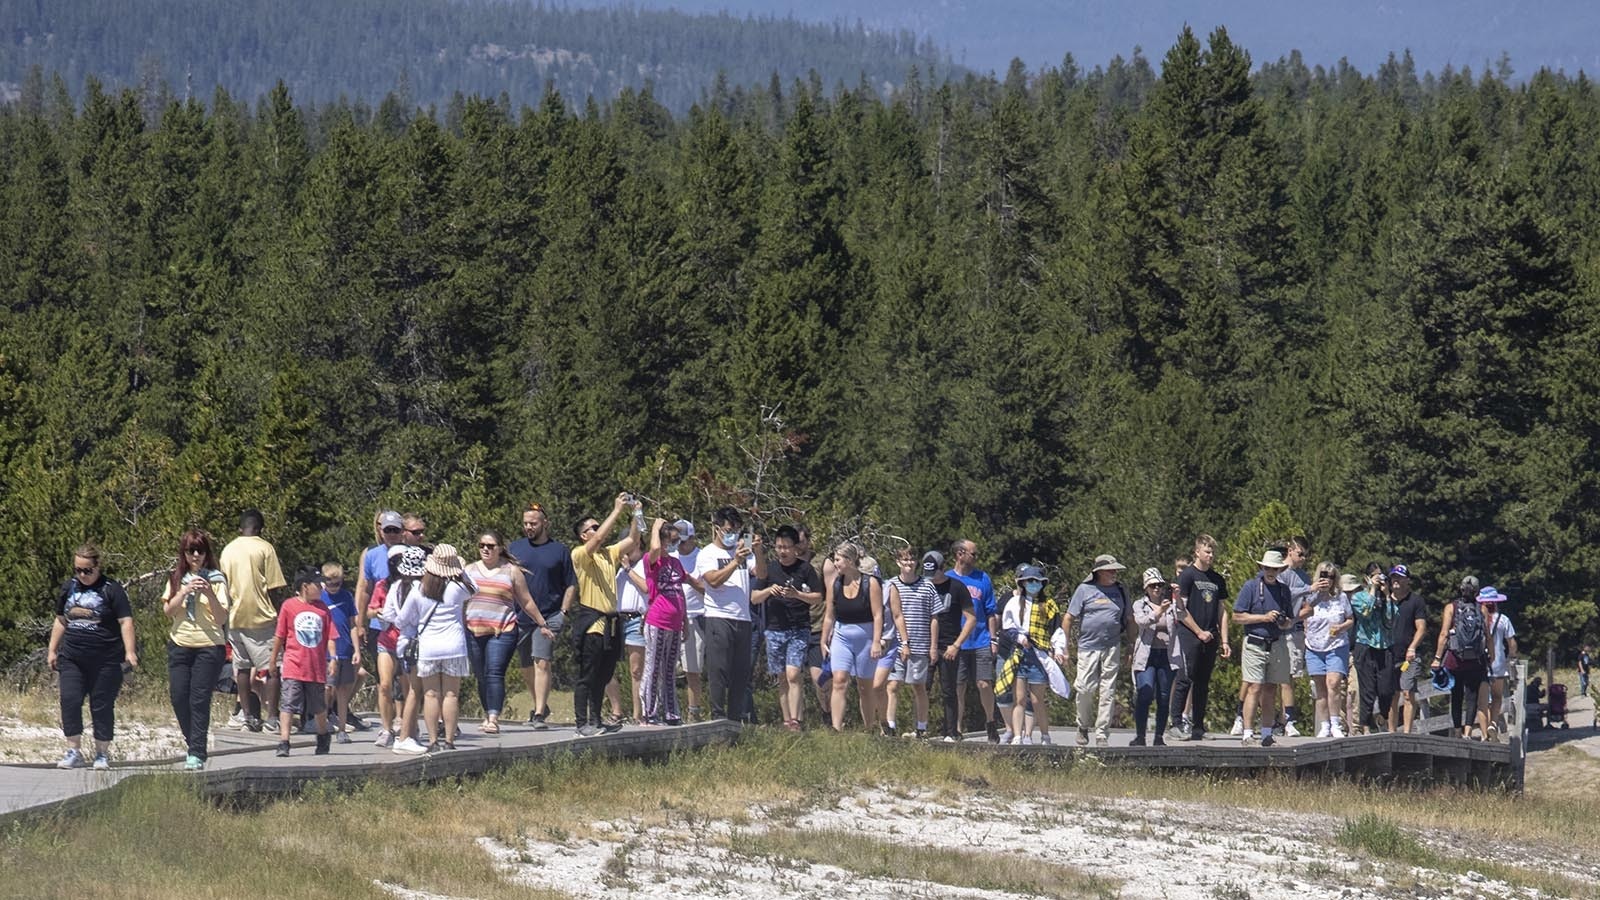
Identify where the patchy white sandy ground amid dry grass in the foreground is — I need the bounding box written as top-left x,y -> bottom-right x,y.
360,790 -> 1600,900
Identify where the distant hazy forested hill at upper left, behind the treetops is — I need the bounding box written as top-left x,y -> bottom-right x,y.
0,0 -> 946,114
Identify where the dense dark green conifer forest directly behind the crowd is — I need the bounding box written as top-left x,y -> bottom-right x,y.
0,30 -> 1600,662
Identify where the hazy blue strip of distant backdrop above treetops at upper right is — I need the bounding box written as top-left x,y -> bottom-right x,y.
620,0 -> 1600,75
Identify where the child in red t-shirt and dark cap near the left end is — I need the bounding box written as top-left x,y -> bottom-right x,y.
269,569 -> 334,756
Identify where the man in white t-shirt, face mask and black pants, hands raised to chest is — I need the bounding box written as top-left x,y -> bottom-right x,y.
690,506 -> 766,722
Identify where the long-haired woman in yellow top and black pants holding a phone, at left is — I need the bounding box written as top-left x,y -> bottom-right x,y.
162,528 -> 230,772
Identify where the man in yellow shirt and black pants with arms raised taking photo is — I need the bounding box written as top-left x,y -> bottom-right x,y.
563,493 -> 642,737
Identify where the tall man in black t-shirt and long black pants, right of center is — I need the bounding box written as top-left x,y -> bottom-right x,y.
1173,535 -> 1234,740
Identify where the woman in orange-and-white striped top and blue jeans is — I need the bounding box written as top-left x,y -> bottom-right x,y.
466,530 -> 555,735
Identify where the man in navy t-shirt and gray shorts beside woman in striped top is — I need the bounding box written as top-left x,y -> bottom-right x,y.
507,503 -> 578,730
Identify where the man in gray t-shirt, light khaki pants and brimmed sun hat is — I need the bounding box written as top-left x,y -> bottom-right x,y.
1061,554 -> 1133,746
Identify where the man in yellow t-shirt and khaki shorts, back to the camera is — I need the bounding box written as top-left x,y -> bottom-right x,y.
218,509 -> 288,732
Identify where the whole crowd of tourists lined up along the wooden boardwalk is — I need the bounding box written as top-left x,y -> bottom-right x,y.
48,493 -> 1517,769
